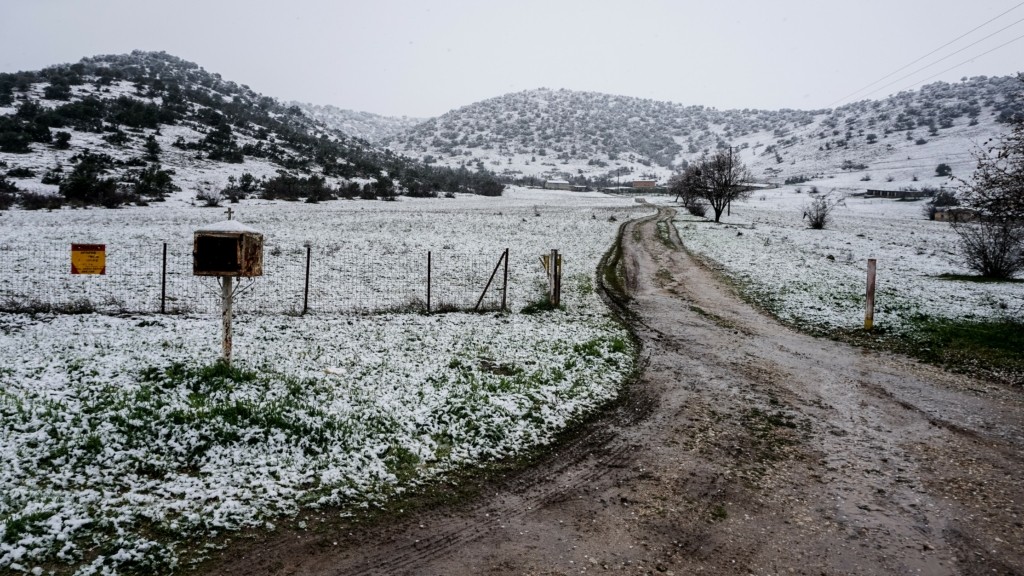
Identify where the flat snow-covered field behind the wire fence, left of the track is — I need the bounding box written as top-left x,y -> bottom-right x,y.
0,189 -> 638,313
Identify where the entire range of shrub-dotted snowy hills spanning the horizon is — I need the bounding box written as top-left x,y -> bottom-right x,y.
0,51 -> 1024,208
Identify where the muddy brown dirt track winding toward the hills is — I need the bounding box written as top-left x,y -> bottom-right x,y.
195,209 -> 1024,575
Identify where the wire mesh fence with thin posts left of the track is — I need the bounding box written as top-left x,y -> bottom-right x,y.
0,242 -> 544,314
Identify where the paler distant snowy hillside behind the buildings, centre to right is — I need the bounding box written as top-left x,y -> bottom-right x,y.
387,76 -> 1024,187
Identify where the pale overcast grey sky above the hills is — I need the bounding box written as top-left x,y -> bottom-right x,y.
0,0 -> 1024,117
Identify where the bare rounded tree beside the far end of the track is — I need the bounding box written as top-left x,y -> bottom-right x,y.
669,148 -> 753,222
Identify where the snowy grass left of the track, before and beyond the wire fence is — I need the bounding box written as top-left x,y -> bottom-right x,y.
0,190 -> 650,574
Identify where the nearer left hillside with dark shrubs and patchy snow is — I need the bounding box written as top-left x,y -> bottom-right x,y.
0,51 -> 503,209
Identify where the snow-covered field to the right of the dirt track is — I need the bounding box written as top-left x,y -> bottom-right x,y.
676,187 -> 1024,333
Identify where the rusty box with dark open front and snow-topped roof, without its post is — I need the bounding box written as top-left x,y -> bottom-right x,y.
193,220 -> 263,278
